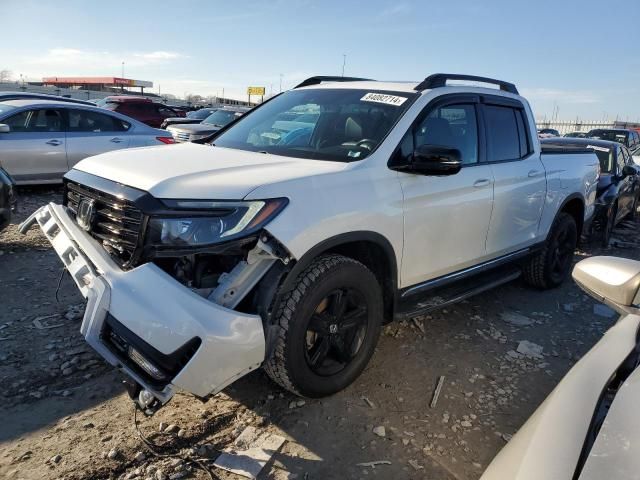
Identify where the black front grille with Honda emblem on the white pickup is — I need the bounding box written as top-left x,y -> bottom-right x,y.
66,182 -> 143,265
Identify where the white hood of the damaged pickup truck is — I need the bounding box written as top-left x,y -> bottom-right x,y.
74,143 -> 349,200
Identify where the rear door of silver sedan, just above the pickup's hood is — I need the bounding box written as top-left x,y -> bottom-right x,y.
65,108 -> 131,168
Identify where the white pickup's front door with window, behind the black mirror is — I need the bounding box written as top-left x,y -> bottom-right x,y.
398,96 -> 494,286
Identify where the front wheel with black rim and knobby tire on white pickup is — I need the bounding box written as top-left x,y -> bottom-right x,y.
264,254 -> 383,398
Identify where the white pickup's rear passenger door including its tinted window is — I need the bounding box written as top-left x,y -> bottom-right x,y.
481,96 -> 547,257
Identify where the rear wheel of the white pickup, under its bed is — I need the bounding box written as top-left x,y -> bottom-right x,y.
522,212 -> 578,289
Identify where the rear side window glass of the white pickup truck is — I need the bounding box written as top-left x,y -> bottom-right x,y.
484,105 -> 524,162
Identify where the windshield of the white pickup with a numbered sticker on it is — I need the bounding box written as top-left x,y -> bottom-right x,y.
215,88 -> 418,162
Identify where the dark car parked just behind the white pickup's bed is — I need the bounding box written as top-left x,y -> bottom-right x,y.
542,138 -> 640,247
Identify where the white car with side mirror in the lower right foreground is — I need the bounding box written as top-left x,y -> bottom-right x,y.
480,257 -> 640,480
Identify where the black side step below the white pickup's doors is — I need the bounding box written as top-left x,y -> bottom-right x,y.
395,266 -> 522,320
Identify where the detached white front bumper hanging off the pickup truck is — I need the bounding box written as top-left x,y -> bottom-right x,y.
20,203 -> 265,403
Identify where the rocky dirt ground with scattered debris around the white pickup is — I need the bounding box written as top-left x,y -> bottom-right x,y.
0,189 -> 640,480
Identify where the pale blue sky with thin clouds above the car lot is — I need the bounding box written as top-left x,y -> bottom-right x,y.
0,0 -> 640,121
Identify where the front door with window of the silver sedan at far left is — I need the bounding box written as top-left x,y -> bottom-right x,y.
0,108 -> 67,183
